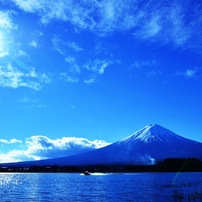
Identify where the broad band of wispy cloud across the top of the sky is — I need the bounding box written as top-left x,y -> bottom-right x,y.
10,0 -> 202,50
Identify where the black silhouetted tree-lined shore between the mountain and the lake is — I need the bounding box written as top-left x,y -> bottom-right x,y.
0,158 -> 202,173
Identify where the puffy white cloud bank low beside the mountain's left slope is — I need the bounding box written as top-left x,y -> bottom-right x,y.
0,135 -> 109,163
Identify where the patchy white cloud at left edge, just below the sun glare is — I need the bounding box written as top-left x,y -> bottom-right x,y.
0,64 -> 50,90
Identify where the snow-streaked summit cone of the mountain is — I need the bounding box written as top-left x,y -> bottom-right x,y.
120,124 -> 189,142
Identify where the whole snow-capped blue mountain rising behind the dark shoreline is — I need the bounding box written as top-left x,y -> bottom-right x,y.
3,124 -> 202,165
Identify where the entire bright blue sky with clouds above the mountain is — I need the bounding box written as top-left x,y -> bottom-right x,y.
0,0 -> 202,162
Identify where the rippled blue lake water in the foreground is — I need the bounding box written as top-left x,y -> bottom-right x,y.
0,173 -> 202,202
